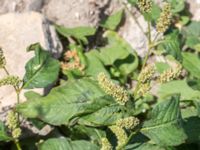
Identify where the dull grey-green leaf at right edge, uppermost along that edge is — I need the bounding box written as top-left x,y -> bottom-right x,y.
183,21 -> 200,48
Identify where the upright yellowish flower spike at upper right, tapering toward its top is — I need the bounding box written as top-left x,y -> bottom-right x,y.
156,3 -> 172,33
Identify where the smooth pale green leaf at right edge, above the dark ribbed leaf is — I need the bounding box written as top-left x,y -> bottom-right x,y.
158,80 -> 200,100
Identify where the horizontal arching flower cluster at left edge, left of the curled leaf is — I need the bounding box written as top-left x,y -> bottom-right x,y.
0,76 -> 22,87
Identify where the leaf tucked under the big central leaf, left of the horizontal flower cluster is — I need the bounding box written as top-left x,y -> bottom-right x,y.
80,106 -> 123,126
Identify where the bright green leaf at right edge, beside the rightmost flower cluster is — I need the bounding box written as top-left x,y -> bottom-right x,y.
182,52 -> 200,78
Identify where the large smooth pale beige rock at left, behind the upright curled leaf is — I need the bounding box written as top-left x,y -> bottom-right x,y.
0,12 -> 62,112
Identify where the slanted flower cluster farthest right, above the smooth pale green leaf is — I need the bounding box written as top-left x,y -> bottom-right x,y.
158,64 -> 182,83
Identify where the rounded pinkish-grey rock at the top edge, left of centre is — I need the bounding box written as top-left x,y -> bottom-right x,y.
43,0 -> 98,27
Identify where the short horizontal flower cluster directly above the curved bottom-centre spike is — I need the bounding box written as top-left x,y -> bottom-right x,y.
116,117 -> 140,129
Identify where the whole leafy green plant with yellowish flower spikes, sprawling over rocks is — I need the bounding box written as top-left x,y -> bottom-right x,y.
0,0 -> 200,150
